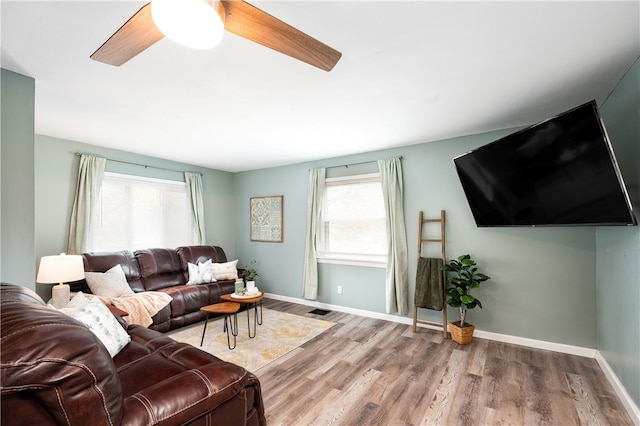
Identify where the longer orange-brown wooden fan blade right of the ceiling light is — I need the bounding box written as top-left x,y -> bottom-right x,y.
222,0 -> 342,71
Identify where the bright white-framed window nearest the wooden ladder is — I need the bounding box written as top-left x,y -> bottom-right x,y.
317,173 -> 387,267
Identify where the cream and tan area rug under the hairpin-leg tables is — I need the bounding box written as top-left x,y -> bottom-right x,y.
167,309 -> 335,372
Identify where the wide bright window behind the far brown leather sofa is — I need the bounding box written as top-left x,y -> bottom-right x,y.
89,173 -> 196,251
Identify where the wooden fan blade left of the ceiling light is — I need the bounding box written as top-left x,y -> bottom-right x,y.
91,3 -> 164,66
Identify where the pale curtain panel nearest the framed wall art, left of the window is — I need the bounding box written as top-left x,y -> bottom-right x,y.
302,168 -> 326,300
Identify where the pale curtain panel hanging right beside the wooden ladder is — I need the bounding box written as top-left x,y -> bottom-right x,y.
378,158 -> 409,315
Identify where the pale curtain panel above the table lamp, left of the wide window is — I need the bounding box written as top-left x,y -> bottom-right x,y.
67,154 -> 107,254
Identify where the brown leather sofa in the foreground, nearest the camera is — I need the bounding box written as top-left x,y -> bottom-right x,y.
0,283 -> 266,426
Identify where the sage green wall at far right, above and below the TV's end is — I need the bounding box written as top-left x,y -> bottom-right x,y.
596,55 -> 640,406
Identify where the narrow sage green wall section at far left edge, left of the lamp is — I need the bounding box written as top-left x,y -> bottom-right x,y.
0,69 -> 36,289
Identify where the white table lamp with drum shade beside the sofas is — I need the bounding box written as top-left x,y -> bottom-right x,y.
36,253 -> 84,308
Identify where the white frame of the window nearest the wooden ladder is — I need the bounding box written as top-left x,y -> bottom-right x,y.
316,172 -> 388,268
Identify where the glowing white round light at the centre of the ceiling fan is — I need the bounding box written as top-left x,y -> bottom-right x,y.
151,0 -> 224,49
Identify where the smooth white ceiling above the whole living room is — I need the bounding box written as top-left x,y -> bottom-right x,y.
0,0 -> 640,171
